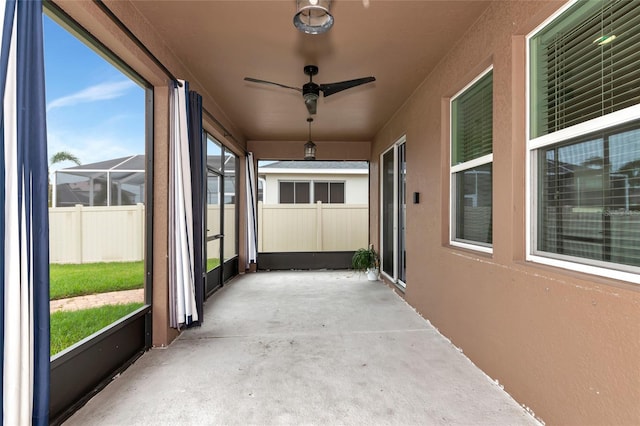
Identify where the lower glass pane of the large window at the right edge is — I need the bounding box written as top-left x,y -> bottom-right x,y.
538,118 -> 640,266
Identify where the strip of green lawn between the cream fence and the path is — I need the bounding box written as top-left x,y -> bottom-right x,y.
49,261 -> 144,300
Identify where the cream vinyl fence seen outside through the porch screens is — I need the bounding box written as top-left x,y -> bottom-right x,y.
49,203 -> 369,263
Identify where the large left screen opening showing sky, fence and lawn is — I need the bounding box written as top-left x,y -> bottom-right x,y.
43,10 -> 153,354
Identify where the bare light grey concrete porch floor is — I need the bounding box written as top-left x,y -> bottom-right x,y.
65,271 -> 539,426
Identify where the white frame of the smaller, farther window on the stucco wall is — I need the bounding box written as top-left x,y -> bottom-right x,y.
449,65 -> 493,254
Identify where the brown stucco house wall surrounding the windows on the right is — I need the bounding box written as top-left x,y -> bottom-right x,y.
370,1 -> 640,425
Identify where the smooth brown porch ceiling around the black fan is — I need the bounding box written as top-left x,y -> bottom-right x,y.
132,0 -> 489,141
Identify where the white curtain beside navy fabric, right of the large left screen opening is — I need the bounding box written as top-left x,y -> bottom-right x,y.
169,80 -> 198,328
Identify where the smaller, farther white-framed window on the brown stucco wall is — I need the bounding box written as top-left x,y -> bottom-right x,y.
451,69 -> 493,252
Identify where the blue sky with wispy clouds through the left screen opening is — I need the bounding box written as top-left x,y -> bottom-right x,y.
44,15 -> 145,170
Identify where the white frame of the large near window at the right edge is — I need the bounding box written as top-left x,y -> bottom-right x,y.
525,0 -> 640,284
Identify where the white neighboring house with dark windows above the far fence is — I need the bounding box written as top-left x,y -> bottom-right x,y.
258,161 -> 369,204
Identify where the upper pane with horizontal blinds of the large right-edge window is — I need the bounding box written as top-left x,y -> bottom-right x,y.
530,0 -> 640,138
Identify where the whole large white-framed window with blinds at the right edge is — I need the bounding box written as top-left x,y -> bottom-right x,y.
528,1 -> 640,282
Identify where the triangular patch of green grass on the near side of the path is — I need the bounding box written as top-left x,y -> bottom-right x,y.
51,303 -> 143,355
